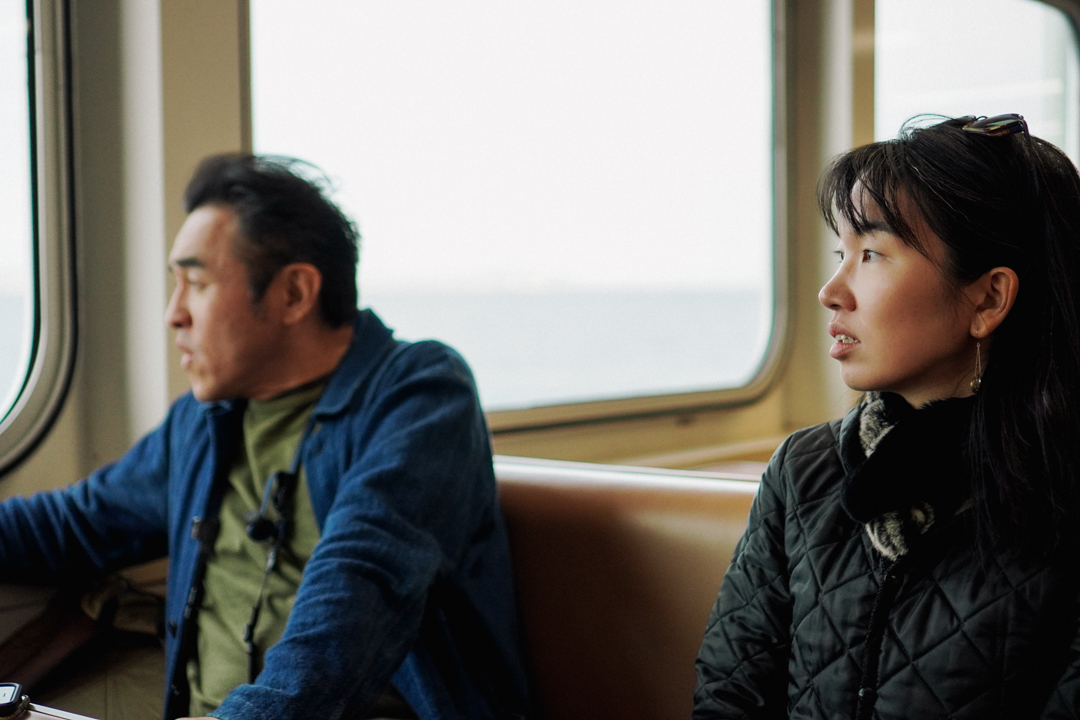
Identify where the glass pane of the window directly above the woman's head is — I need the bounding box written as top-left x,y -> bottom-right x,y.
874,0 -> 1080,162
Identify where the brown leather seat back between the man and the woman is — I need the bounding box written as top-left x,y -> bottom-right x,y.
496,457 -> 758,720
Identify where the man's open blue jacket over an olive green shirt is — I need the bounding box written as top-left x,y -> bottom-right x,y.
0,311 -> 527,720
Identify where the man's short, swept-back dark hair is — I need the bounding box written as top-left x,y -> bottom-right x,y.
184,153 -> 360,327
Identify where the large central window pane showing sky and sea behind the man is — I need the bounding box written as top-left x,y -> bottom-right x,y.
251,0 -> 773,409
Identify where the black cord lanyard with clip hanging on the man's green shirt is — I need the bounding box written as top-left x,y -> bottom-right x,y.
244,415 -> 314,683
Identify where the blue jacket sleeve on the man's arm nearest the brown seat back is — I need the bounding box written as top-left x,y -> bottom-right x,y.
213,343 -> 509,720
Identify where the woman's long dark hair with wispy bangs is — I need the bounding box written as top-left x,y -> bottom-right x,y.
819,118 -> 1080,553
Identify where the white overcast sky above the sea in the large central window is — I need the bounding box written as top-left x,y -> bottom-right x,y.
252,0 -> 772,293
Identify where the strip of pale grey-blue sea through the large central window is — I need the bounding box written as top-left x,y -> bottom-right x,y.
362,289 -> 772,410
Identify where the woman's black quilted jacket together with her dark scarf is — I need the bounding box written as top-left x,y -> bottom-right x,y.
693,400 -> 1080,720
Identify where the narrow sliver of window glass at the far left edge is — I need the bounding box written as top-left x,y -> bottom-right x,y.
0,5 -> 35,418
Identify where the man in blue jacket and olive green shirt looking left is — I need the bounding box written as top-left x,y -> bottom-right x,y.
0,155 -> 526,720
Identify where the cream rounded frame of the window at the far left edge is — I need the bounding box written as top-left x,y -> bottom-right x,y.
0,0 -> 77,475
